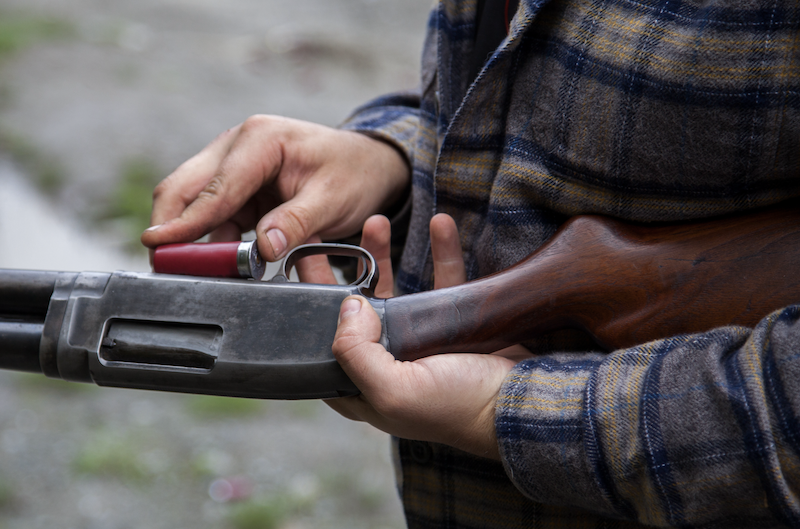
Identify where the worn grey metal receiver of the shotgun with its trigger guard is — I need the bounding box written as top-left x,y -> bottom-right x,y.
0,244 -> 386,399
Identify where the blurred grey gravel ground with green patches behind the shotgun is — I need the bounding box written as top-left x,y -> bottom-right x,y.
0,0 -> 431,529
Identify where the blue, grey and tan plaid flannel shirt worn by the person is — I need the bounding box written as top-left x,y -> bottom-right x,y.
344,0 -> 800,528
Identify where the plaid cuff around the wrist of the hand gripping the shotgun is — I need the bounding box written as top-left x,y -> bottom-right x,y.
495,353 -> 619,516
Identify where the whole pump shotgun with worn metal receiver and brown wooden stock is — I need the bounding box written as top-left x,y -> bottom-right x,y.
0,205 -> 800,399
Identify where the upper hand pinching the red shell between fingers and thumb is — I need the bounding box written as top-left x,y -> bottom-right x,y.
142,116 -> 410,261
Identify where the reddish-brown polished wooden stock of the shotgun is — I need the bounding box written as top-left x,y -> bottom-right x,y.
386,205 -> 800,360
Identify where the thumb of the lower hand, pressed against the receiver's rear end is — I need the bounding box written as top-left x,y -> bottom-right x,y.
332,296 -> 395,393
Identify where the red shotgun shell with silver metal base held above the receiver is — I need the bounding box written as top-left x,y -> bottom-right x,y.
153,241 -> 266,280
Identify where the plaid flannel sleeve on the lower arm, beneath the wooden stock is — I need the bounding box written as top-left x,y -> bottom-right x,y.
496,306 -> 800,527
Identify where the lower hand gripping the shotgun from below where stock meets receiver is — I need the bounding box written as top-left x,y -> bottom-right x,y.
327,215 -> 529,459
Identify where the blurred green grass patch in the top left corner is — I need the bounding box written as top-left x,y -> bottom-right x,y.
0,11 -> 76,58
